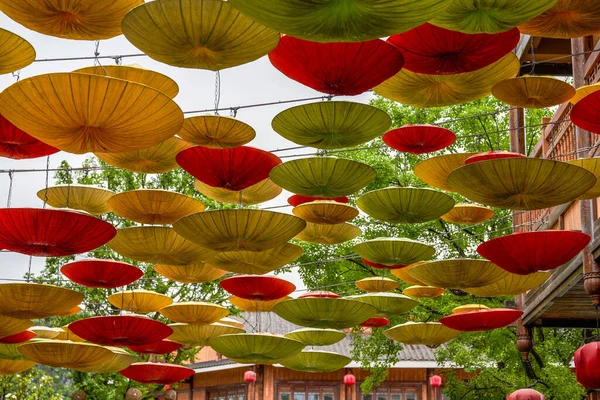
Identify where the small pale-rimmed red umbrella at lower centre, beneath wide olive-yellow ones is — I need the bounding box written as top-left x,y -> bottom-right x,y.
220,275 -> 296,301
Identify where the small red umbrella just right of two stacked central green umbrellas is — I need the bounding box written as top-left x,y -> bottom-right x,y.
382,124 -> 456,154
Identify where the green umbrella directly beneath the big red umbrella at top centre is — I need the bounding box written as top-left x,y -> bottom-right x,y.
271,101 -> 392,149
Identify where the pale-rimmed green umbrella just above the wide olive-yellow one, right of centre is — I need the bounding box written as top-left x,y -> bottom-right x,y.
354,238 -> 435,266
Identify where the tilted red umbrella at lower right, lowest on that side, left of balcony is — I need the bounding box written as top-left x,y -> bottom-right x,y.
440,308 -> 523,332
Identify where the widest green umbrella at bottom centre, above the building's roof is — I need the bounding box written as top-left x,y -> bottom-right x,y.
210,333 -> 304,364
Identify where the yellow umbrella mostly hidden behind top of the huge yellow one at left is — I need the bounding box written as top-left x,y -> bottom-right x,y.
73,65 -> 179,98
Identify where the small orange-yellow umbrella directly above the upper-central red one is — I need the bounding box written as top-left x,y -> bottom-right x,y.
179,115 -> 256,149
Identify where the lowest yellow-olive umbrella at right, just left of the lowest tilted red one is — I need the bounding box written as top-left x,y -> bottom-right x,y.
383,322 -> 460,346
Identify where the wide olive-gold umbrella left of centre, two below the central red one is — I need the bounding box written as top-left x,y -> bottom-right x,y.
173,209 -> 306,251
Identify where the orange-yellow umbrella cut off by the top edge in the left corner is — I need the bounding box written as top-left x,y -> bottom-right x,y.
0,0 -> 144,40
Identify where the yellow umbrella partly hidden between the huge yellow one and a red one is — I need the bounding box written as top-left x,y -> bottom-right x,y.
94,137 -> 191,174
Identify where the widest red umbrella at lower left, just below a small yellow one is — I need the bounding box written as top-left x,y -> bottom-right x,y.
69,315 -> 173,346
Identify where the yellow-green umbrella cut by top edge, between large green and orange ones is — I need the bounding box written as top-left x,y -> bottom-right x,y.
430,0 -> 557,33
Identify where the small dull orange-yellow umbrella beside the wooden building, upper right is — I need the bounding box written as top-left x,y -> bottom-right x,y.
492,75 -> 575,108
